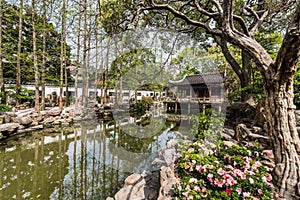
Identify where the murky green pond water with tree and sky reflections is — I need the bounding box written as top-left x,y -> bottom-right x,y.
0,111 -> 185,200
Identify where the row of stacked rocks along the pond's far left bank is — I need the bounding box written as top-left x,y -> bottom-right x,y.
0,106 -> 101,141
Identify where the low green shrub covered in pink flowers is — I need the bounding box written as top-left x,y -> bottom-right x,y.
174,142 -> 274,200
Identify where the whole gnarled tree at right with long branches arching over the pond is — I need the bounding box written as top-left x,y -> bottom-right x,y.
104,0 -> 300,199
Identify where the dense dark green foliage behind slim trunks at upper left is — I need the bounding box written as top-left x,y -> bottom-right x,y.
1,2 -> 71,83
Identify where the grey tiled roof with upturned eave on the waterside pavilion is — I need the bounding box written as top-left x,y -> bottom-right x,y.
169,73 -> 224,86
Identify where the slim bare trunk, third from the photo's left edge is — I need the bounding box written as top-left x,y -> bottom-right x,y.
31,0 -> 40,112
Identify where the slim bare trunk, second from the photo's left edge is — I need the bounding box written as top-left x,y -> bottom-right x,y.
16,0 -> 23,105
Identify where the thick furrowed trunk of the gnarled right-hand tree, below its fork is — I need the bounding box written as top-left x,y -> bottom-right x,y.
265,73 -> 300,199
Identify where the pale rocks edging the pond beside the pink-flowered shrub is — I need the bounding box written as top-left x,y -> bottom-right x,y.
106,139 -> 191,200
